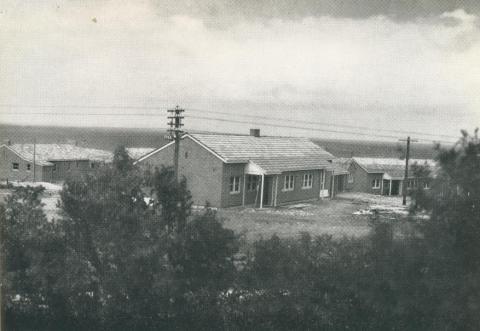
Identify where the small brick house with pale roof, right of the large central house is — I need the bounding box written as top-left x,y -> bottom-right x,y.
346,157 -> 435,195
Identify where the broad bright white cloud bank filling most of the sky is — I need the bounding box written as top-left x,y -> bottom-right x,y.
0,2 -> 480,139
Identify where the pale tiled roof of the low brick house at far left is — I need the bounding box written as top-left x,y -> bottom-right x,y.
7,144 -> 113,165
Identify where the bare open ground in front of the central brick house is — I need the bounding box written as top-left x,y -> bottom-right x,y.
218,193 -> 414,242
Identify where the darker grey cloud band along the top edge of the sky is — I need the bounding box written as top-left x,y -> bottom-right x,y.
149,0 -> 480,25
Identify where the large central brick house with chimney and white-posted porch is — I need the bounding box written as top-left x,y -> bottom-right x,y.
136,130 -> 333,208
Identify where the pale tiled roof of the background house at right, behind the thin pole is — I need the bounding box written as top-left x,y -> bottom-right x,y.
353,157 -> 436,178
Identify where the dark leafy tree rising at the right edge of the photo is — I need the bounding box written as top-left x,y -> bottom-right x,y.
421,129 -> 480,272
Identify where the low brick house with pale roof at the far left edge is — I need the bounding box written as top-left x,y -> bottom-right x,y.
0,144 -> 113,182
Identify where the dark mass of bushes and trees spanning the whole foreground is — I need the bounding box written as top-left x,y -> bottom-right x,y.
0,132 -> 480,330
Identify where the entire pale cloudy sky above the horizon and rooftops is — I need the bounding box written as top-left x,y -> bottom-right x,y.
0,0 -> 480,141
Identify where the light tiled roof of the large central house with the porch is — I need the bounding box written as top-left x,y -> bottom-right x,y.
190,134 -> 333,173
